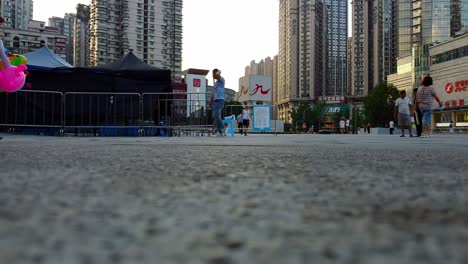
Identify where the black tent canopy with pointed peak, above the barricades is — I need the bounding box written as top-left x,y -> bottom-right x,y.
27,52 -> 172,93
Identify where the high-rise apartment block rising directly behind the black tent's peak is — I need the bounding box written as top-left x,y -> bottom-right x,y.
90,0 -> 182,79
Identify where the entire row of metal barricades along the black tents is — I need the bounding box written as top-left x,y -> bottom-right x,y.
0,90 -> 230,136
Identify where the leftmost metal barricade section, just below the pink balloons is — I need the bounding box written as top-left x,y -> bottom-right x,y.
0,90 -> 64,134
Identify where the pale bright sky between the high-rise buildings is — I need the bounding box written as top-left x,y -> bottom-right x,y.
33,0 -> 351,91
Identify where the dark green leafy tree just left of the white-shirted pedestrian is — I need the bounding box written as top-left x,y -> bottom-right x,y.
364,82 -> 399,126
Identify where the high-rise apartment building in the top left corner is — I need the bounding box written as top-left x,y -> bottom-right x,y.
0,0 -> 33,30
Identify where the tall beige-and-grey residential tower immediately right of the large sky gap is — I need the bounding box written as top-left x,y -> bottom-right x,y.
275,0 -> 347,122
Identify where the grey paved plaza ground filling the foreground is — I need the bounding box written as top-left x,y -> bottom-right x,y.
0,134 -> 468,264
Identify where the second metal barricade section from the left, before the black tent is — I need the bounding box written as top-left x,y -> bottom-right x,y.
63,92 -> 141,136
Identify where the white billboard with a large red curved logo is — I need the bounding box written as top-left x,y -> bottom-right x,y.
239,75 -> 273,102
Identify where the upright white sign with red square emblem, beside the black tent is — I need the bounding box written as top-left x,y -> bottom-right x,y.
185,74 -> 206,117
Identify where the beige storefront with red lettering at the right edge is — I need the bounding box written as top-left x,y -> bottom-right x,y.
429,35 -> 468,130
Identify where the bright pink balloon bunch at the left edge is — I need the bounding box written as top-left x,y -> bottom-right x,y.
0,40 -> 27,93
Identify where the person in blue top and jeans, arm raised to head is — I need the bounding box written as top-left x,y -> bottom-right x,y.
212,69 -> 225,136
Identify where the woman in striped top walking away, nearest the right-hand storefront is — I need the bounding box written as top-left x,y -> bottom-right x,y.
416,76 -> 442,138
